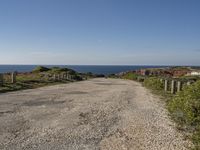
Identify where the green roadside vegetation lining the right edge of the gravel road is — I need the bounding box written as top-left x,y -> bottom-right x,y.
122,73 -> 200,150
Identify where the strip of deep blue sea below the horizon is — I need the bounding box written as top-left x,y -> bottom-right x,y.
0,65 -> 166,75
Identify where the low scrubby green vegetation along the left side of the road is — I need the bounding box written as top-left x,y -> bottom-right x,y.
0,66 -> 94,93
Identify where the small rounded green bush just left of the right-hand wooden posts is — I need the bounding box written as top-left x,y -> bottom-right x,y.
144,77 -> 164,90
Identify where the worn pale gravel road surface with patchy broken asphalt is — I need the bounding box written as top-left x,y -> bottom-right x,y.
0,79 -> 190,150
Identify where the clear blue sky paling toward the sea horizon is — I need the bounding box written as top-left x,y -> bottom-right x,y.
0,0 -> 200,65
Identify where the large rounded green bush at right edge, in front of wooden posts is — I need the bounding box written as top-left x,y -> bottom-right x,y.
169,81 -> 200,126
